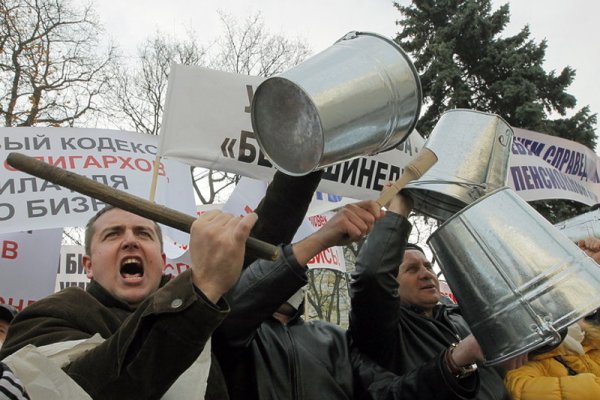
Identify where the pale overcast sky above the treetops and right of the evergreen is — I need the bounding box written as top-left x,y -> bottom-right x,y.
90,0 -> 600,136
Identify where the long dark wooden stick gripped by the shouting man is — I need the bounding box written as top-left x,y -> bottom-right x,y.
6,153 -> 279,261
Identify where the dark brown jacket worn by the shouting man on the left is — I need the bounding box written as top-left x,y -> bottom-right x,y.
0,271 -> 229,400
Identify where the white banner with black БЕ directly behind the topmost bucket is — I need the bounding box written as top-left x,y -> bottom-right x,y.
159,65 -> 425,199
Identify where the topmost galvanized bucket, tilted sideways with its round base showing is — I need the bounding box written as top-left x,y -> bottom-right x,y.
251,32 -> 422,175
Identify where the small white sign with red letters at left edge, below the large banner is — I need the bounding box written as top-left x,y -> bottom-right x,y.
0,229 -> 62,310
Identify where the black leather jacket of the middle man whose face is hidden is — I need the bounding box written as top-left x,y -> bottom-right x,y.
213,247 -> 354,400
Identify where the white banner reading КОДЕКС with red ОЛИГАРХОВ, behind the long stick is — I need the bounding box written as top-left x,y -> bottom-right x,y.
0,127 -> 195,247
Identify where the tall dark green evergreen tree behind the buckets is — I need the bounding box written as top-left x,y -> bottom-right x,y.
394,0 -> 596,222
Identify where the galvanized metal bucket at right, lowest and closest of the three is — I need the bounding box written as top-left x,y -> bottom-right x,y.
428,187 -> 600,364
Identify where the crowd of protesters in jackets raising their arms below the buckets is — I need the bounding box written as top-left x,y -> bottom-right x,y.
0,172 -> 600,400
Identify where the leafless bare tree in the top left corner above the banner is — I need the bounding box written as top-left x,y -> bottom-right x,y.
0,0 -> 116,126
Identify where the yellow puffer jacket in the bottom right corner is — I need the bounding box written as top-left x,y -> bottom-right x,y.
504,324 -> 600,400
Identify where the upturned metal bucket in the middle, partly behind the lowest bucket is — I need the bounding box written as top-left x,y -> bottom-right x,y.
404,109 -> 514,221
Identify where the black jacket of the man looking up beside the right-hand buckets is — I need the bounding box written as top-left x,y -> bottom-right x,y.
350,212 -> 509,399
